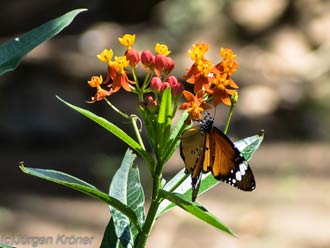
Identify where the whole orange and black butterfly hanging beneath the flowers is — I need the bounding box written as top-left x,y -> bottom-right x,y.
180,115 -> 256,201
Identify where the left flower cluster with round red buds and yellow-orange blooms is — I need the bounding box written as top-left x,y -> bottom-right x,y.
88,34 -> 184,109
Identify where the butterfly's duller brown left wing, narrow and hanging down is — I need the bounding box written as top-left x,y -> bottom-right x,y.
180,125 -> 206,201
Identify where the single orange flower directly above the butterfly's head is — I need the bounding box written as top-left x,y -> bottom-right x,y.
180,90 -> 211,121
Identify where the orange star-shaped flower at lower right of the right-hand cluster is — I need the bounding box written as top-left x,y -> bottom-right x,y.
205,73 -> 238,106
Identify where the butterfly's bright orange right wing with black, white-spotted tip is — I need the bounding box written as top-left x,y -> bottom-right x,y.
210,127 -> 256,191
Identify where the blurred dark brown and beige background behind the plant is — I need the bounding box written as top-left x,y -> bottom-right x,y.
0,0 -> 330,248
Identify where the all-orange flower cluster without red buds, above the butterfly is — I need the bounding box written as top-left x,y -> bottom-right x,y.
180,42 -> 238,120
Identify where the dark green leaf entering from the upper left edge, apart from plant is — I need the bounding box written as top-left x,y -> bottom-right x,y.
0,9 -> 87,76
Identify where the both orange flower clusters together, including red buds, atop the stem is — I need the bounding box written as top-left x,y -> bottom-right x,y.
88,34 -> 238,120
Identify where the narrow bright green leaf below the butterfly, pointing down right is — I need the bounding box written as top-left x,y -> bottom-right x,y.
159,190 -> 235,236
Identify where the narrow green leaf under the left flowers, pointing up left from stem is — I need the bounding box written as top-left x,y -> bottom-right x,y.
57,96 -> 154,171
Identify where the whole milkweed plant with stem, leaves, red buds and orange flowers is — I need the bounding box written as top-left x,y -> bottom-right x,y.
0,8 -> 263,247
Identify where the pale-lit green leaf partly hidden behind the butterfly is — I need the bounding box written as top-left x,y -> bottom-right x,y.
157,132 -> 264,216
